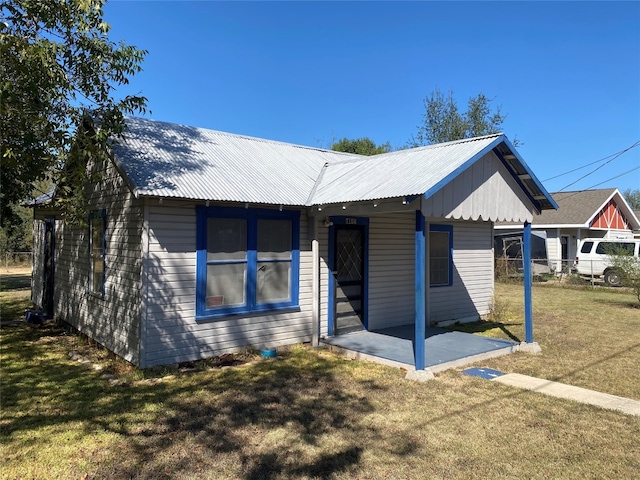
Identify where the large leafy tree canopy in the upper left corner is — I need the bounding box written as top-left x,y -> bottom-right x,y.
0,0 -> 147,218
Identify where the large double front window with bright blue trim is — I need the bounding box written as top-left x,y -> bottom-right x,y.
196,207 -> 300,318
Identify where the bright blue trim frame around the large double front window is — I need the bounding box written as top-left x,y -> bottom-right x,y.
196,205 -> 300,320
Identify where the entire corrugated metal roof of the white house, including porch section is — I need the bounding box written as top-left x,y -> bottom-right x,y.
113,118 -> 555,210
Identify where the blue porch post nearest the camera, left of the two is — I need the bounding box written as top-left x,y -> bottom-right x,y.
414,210 -> 427,370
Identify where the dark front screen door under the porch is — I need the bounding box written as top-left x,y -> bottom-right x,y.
333,225 -> 365,335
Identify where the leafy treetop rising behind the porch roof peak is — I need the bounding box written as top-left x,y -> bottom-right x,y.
408,88 -> 521,147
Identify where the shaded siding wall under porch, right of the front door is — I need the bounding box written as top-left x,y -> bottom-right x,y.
369,213 -> 493,330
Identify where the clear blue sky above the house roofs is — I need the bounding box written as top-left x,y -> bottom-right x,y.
105,0 -> 640,192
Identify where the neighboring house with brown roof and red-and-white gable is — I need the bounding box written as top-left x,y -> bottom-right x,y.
495,188 -> 640,272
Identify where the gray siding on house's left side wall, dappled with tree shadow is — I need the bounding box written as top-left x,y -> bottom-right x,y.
54,158 -> 142,364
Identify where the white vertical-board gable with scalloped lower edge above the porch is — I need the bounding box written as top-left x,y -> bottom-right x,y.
422,152 -> 533,223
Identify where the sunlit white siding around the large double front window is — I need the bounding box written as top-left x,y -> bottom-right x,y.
142,201 -> 318,367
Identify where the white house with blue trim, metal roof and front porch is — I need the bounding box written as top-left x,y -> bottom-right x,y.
32,119 -> 555,369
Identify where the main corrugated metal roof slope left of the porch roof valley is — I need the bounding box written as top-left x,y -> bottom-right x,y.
113,118 -> 354,205
